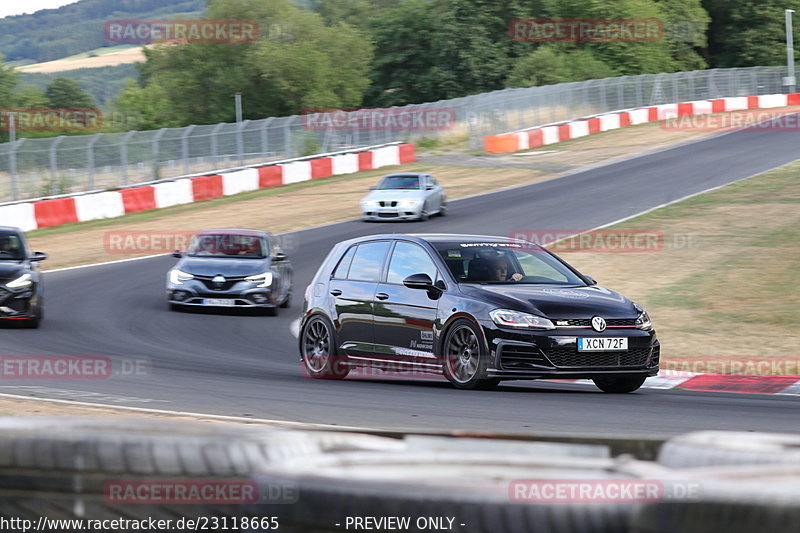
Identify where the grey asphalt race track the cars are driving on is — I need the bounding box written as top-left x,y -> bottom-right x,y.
0,117 -> 800,436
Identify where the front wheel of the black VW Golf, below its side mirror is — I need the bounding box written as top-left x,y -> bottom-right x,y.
442,320 -> 500,390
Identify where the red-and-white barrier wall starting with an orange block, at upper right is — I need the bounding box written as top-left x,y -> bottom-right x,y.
483,93 -> 800,154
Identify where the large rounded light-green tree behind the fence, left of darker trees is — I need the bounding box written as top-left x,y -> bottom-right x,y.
117,0 -> 372,127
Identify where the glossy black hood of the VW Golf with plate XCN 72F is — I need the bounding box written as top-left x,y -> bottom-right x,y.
462,284 -> 638,318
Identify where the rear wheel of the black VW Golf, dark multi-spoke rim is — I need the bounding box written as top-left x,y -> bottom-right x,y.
300,315 -> 350,379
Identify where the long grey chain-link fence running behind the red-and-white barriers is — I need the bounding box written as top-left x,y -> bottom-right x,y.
0,67 -> 786,202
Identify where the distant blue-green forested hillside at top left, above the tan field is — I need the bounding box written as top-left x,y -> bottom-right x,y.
0,0 -> 206,63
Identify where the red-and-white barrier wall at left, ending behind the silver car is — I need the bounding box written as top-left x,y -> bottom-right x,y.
0,144 -> 416,231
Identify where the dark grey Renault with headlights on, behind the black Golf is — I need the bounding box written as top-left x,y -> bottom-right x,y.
167,229 -> 293,315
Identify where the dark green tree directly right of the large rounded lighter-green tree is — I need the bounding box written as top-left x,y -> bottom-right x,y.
366,0 -> 541,106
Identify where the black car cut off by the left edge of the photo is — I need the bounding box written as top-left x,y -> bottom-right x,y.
0,226 -> 47,328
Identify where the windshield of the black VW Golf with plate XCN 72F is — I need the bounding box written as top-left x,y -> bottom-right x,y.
433,242 -> 586,285
